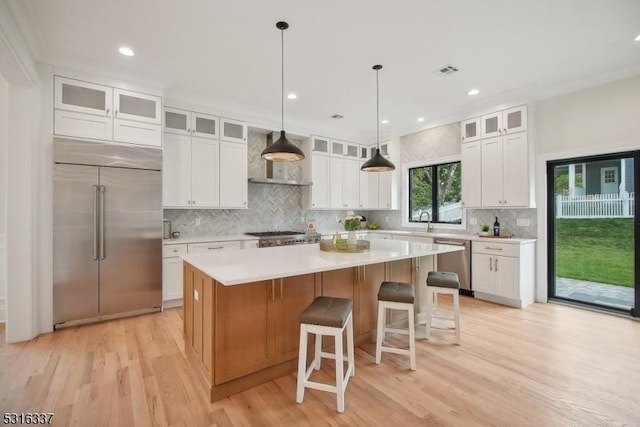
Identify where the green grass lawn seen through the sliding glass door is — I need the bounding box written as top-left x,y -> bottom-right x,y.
556,218 -> 633,287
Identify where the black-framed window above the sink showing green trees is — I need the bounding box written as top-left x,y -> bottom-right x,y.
408,162 -> 462,224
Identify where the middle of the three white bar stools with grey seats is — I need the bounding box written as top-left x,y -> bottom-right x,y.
376,282 -> 416,371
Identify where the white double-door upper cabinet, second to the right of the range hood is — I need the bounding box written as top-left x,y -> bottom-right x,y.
330,157 -> 360,209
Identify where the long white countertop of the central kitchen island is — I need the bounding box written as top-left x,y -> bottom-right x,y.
182,239 -> 463,286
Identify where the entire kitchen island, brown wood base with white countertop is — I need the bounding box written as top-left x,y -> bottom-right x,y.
183,240 -> 461,402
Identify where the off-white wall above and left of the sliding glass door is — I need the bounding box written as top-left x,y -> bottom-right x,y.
536,76 -> 640,301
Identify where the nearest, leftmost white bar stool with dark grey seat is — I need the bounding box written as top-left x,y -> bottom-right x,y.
296,297 -> 356,412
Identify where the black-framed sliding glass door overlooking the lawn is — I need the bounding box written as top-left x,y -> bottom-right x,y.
547,151 -> 640,316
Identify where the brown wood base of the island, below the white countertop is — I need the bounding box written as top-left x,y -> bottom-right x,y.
183,258 -> 420,402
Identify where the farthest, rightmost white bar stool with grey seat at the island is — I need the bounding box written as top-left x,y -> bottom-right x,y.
426,271 -> 460,345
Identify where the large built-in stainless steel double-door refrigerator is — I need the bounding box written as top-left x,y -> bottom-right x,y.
53,140 -> 162,328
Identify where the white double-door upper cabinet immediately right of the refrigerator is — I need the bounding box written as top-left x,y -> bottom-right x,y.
162,134 -> 220,208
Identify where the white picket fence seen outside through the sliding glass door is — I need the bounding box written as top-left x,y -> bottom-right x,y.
556,192 -> 635,218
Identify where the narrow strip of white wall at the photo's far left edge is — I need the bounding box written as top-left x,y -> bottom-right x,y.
0,74 -> 9,323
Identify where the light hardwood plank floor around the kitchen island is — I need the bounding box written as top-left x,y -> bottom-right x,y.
0,297 -> 640,426
